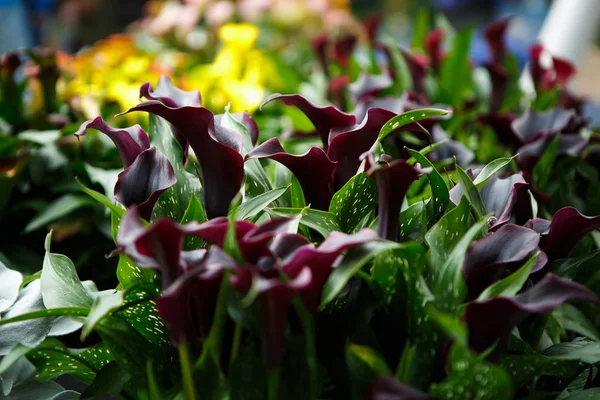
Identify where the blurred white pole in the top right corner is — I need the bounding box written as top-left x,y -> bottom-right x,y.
520,0 -> 600,94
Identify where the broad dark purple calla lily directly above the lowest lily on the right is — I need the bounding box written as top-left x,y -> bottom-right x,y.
462,224 -> 547,299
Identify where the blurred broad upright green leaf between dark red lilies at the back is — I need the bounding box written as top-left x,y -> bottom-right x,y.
439,28 -> 472,109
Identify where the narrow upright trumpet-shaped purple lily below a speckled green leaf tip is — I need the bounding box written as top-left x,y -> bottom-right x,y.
363,153 -> 427,242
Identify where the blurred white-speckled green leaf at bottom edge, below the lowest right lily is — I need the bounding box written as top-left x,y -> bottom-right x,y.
430,343 -> 512,400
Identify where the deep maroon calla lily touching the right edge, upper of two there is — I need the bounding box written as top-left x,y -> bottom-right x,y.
526,207 -> 600,260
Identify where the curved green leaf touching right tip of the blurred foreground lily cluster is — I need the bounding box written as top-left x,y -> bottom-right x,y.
320,241 -> 405,309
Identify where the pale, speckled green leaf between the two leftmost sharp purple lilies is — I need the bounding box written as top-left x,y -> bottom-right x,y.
149,114 -> 202,221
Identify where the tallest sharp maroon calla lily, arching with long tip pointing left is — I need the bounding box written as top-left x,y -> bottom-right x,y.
127,79 -> 244,218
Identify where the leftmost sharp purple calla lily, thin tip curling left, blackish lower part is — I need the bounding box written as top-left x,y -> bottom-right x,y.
75,117 -> 177,220
